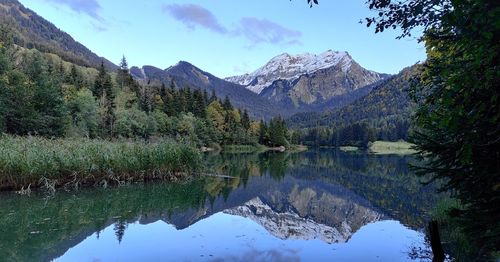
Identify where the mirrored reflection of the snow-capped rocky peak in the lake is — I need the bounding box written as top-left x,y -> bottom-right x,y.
223,185 -> 383,243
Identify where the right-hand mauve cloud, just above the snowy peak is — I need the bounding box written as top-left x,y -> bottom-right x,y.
238,17 -> 302,45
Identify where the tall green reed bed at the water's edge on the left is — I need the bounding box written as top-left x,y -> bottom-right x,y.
0,135 -> 200,190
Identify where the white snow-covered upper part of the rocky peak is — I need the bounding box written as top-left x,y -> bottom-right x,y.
226,50 -> 353,93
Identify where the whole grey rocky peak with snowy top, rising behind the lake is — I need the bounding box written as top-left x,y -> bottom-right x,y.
226,50 -> 387,111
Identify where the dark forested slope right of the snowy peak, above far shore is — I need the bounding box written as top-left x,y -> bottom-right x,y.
288,65 -> 421,147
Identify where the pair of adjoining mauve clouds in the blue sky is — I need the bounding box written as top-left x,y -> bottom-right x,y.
162,4 -> 302,47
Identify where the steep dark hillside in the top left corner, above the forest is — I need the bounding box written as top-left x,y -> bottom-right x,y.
0,0 -> 118,70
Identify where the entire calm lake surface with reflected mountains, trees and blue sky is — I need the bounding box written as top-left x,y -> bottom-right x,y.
0,149 -> 437,261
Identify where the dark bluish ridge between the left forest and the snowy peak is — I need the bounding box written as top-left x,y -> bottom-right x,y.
130,61 -> 287,119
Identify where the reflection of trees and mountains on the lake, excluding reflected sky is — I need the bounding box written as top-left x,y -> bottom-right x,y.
0,150 -> 437,261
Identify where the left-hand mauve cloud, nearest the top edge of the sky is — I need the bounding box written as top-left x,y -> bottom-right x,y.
163,4 -> 228,34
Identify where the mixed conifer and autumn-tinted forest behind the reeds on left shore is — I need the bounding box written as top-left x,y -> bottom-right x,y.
0,28 -> 289,148
